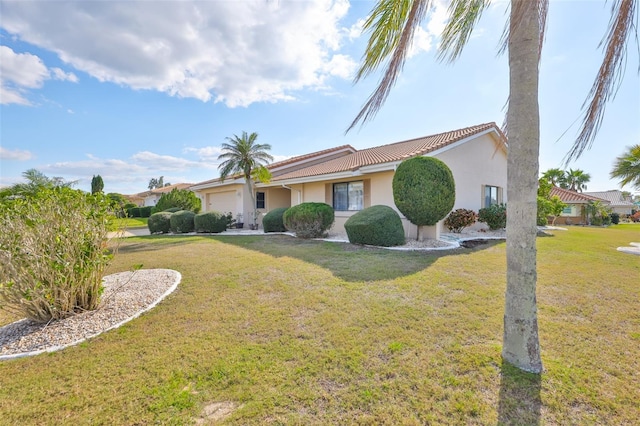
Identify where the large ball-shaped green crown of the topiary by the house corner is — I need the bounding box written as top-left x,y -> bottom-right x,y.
393,157 -> 456,226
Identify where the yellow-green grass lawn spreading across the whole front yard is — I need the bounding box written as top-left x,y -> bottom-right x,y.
0,225 -> 640,425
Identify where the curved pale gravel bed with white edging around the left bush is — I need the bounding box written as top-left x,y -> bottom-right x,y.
0,269 -> 181,360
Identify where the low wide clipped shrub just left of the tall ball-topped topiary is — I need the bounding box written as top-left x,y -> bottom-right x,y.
344,206 -> 405,247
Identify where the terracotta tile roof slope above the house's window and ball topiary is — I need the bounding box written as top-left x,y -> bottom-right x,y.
273,123 -> 506,181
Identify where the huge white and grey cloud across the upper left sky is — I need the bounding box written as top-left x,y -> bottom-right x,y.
2,0 -> 354,107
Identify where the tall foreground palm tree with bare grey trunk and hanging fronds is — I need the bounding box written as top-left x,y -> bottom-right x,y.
347,0 -> 637,373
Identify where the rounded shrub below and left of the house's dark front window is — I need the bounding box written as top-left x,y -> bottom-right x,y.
282,203 -> 335,238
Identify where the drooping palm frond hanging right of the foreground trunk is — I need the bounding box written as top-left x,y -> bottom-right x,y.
565,0 -> 638,164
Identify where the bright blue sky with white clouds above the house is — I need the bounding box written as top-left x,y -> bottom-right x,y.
0,0 -> 640,194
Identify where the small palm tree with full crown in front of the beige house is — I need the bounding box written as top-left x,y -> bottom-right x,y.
218,132 -> 273,230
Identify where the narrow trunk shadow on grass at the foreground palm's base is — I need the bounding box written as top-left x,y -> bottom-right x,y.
498,361 -> 542,425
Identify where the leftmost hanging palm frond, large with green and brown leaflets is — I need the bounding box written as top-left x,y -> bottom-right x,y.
347,0 -> 431,132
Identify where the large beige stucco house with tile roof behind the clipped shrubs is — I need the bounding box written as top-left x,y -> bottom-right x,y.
191,123 -> 507,238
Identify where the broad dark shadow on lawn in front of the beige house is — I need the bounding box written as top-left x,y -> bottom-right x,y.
213,235 -> 499,282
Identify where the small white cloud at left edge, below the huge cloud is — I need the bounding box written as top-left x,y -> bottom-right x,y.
0,46 -> 78,105
